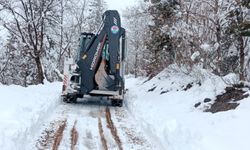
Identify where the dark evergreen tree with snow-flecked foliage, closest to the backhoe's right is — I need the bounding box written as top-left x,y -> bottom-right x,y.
146,1 -> 178,76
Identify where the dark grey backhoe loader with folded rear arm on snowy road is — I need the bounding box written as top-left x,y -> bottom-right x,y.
62,10 -> 126,107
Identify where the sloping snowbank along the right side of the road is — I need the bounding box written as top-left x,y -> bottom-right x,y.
126,66 -> 250,150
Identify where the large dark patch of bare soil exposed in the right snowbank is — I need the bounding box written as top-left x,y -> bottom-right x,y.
205,86 -> 249,113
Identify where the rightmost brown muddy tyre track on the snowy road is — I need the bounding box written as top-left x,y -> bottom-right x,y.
106,107 -> 123,150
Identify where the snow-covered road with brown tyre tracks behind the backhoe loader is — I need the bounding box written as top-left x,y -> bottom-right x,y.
31,98 -> 155,150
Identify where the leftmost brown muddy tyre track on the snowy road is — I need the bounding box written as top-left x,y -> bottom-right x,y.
52,120 -> 67,150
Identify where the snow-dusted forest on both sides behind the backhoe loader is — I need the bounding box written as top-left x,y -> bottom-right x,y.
0,0 -> 250,86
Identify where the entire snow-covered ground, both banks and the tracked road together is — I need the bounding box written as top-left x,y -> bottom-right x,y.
0,68 -> 250,150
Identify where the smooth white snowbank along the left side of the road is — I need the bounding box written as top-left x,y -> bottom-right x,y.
0,83 -> 61,150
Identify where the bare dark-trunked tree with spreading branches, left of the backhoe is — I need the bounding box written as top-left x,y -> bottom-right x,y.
0,0 -> 56,83
